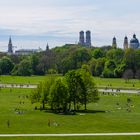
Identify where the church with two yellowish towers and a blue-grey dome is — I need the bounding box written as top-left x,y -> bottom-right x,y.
112,34 -> 140,50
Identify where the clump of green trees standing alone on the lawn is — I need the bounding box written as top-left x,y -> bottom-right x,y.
31,66 -> 99,113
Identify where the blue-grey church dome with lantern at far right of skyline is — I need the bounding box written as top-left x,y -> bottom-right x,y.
130,34 -> 140,49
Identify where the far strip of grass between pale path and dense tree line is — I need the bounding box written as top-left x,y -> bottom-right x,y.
0,75 -> 140,89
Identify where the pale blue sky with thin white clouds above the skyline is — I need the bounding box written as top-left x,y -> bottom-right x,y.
0,0 -> 140,51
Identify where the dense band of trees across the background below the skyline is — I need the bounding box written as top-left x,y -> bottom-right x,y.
0,45 -> 140,79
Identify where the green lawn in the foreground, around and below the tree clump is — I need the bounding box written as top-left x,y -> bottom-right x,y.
0,89 -> 140,140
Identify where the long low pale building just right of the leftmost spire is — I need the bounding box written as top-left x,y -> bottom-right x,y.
15,49 -> 40,55
